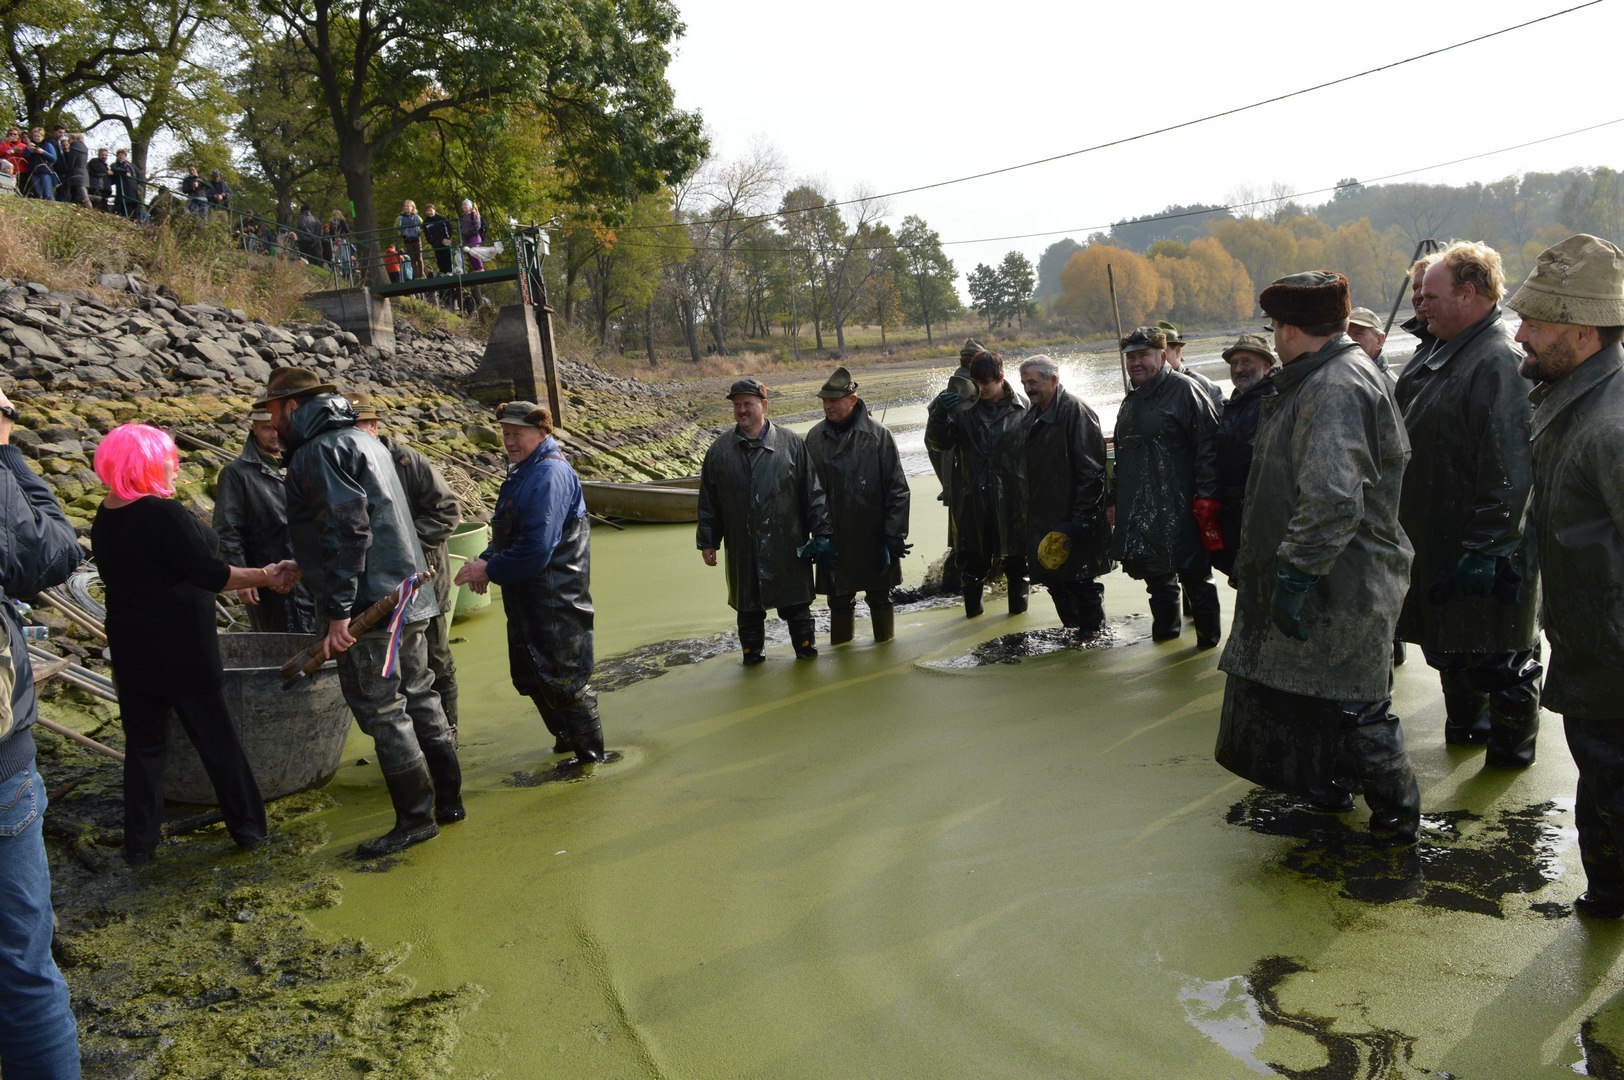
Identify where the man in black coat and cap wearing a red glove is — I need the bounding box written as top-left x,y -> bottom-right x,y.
1109,326 -> 1223,648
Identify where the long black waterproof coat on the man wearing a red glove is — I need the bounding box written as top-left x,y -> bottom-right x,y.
1111,365 -> 1218,578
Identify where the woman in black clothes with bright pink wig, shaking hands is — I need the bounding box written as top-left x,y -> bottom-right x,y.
91,424 -> 299,866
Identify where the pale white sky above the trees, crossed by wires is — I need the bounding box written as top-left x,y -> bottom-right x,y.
671,0 -> 1624,282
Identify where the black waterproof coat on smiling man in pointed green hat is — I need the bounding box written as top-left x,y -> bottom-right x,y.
807,398 -> 909,596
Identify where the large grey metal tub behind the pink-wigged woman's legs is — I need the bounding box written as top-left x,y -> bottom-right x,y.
164,633 -> 351,806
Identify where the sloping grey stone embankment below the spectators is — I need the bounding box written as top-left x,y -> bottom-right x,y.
0,274 -> 713,531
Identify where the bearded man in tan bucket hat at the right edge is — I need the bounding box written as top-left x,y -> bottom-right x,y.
1505,234 -> 1624,919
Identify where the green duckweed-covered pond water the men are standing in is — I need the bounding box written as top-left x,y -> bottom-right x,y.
312,357 -> 1624,1078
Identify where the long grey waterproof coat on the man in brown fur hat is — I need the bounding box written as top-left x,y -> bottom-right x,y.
1214,335 -> 1411,702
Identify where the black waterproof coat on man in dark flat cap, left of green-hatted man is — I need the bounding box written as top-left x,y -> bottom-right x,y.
695,421 -> 838,611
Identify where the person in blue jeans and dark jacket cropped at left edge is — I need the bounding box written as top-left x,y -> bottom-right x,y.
0,383 -> 80,1080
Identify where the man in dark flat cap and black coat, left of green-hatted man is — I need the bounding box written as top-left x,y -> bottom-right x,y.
695,378 -> 836,667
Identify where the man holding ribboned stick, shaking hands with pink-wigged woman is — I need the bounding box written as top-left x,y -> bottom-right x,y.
253,367 -> 468,859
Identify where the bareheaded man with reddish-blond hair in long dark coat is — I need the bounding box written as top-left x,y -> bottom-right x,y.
1395,242 -> 1541,768
